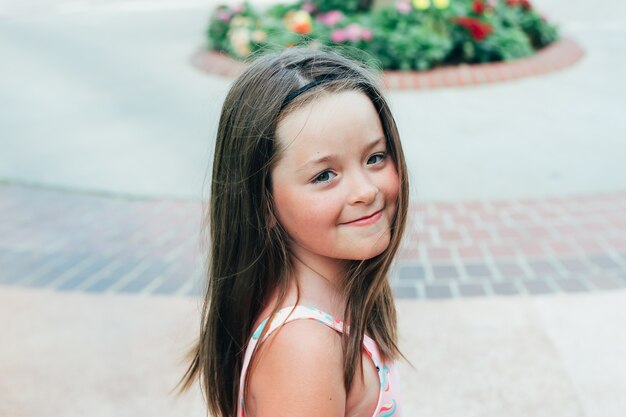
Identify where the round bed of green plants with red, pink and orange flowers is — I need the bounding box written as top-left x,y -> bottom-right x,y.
207,0 -> 558,70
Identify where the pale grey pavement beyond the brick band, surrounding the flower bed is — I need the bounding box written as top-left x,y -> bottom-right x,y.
0,0 -> 626,201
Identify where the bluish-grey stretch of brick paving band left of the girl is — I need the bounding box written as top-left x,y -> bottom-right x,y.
0,185 -> 202,295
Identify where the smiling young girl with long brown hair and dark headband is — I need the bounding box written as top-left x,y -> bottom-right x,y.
182,49 -> 408,417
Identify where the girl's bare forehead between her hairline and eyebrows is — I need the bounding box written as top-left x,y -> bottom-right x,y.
276,91 -> 384,163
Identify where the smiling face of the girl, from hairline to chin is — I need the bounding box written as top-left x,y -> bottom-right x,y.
271,91 -> 399,268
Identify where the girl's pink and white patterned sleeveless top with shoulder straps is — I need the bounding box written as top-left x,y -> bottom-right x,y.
237,305 -> 401,417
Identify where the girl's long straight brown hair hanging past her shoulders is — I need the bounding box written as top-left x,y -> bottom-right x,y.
180,48 -> 409,417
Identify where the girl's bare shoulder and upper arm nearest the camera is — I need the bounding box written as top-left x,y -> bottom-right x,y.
246,320 -> 346,417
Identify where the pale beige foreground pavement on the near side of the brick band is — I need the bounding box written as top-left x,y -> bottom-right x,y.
0,287 -> 626,417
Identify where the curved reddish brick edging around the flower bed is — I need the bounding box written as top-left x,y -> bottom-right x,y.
191,38 -> 584,90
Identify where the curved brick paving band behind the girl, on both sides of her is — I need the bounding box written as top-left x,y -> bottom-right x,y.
0,184 -> 626,299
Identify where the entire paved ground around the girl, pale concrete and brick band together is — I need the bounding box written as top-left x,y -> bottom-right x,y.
0,0 -> 626,417
